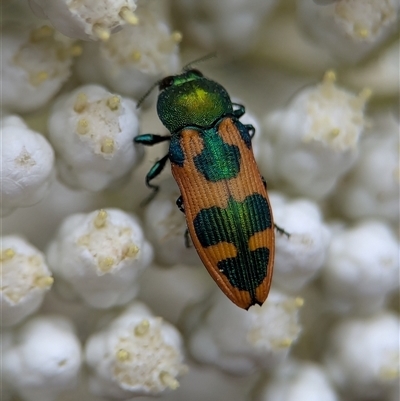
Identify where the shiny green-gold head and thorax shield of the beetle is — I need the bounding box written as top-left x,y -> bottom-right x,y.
157,69 -> 233,133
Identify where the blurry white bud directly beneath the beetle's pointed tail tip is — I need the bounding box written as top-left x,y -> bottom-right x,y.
186,290 -> 303,375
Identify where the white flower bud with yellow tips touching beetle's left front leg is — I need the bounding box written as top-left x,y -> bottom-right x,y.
48,85 -> 142,191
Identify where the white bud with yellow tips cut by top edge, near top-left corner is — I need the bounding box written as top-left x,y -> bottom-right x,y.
29,0 -> 138,40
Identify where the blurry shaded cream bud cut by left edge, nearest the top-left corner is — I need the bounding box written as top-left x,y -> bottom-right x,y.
1,22 -> 81,113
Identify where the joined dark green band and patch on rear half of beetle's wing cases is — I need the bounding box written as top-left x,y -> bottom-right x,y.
193,194 -> 271,299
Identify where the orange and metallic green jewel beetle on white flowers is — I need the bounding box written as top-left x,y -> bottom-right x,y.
134,67 -> 275,309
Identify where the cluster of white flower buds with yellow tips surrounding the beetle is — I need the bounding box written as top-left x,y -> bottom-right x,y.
0,0 -> 400,401
